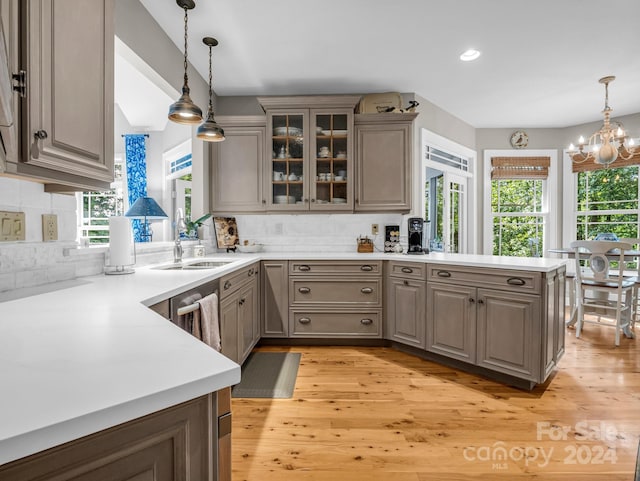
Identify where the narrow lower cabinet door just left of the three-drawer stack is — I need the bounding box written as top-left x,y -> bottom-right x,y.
261,261 -> 289,337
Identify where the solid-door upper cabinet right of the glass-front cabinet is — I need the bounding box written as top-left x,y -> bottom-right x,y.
354,113 -> 418,212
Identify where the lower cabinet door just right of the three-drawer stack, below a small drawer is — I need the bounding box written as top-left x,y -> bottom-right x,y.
385,277 -> 426,349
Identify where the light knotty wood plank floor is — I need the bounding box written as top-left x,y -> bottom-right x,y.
232,325 -> 640,481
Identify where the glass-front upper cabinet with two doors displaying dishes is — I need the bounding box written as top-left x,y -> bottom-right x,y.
258,96 -> 360,211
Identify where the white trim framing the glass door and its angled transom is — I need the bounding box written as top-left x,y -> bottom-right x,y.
415,128 -> 478,254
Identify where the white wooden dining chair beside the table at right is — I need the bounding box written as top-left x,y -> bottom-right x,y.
571,241 -> 635,346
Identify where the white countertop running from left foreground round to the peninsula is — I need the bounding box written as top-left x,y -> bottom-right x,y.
0,252 -> 565,464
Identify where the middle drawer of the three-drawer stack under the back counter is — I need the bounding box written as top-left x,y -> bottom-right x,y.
289,278 -> 382,306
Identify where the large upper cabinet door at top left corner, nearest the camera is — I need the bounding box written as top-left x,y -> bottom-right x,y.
21,0 -> 114,189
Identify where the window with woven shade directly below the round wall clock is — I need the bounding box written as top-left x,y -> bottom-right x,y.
484,149 -> 559,257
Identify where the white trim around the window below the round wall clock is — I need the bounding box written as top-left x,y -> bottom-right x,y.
482,149 -> 556,256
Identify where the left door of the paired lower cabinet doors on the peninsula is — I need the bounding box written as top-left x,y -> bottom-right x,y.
426,282 -> 476,363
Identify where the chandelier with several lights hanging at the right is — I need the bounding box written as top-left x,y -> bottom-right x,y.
567,75 -> 640,167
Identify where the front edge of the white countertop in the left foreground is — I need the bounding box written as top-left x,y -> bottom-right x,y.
0,366 -> 240,466
